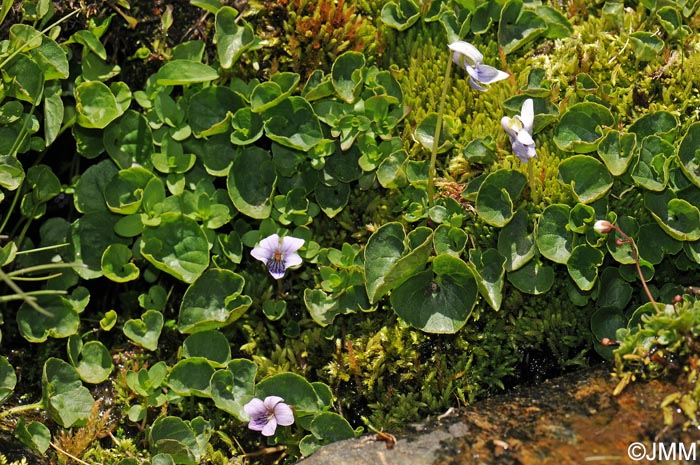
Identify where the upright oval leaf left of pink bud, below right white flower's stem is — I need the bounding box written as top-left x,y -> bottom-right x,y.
535,204 -> 574,263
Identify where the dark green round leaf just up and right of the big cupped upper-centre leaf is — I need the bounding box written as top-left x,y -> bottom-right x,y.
263,96 -> 324,152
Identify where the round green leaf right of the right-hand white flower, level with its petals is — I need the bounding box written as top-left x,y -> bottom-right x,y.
554,102 -> 615,153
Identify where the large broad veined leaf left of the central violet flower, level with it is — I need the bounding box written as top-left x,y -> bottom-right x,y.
141,213 -> 209,283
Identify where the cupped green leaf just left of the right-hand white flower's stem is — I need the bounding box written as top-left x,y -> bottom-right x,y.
476,169 -> 527,228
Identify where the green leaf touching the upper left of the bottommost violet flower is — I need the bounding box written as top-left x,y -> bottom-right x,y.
210,358 -> 258,421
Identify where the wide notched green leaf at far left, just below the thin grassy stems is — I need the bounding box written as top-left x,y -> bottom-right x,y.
17,295 -> 80,342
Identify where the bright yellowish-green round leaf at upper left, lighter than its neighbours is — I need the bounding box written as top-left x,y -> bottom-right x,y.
75,81 -> 123,129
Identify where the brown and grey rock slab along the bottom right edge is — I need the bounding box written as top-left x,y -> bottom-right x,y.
299,366 -> 700,465
